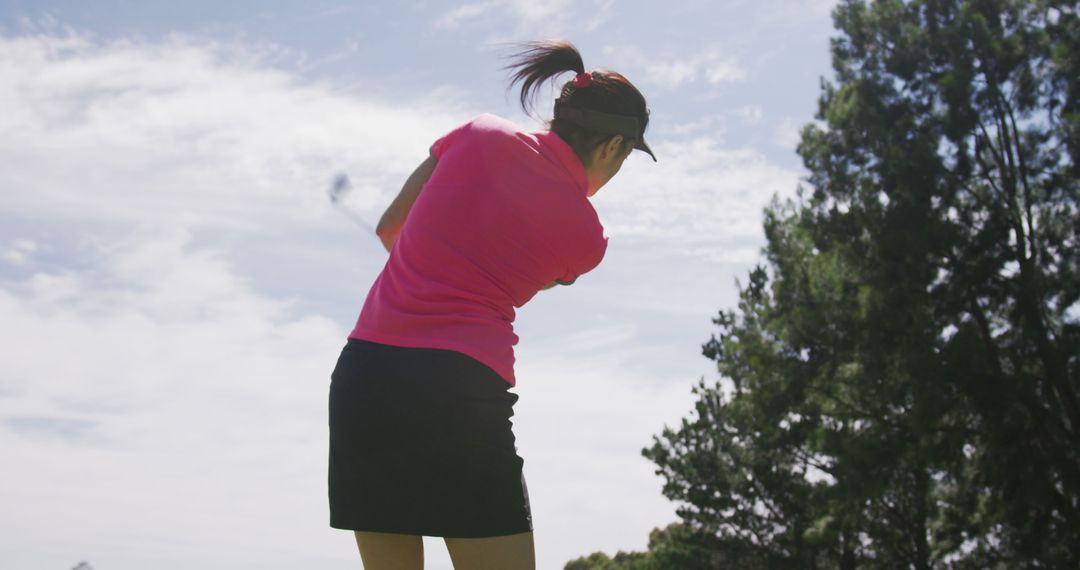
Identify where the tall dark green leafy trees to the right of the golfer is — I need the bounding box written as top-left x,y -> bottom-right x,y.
567,0 -> 1080,569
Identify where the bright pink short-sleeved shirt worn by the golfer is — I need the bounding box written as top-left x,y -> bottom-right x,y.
349,113 -> 607,385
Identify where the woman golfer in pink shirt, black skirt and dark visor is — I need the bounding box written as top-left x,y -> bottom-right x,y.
328,41 -> 656,570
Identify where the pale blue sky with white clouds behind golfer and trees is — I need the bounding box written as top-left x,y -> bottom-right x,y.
0,0 -> 835,570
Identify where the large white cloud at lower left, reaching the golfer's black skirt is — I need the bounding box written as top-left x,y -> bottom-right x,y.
0,225 -> 343,568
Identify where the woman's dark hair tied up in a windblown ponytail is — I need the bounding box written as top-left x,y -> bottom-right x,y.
503,40 -> 649,165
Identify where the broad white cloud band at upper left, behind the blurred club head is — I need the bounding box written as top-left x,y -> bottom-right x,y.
0,30 -> 468,236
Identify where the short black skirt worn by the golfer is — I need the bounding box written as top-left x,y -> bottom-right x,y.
328,339 -> 532,538
